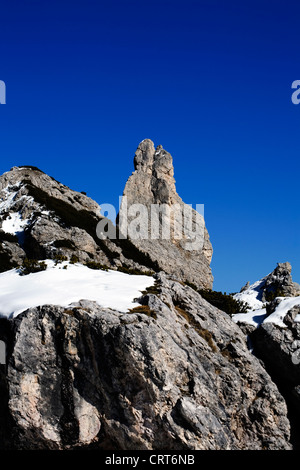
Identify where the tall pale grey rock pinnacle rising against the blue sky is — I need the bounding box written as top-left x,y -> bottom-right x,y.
121,139 -> 213,288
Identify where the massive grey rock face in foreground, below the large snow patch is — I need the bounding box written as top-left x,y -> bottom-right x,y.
0,274 -> 291,450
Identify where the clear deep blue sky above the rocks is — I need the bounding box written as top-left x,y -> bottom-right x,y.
0,0 -> 300,292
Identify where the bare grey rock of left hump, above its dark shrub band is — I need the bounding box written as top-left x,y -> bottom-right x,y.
0,167 -> 106,270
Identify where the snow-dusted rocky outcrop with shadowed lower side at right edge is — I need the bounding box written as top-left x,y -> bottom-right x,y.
233,262 -> 300,450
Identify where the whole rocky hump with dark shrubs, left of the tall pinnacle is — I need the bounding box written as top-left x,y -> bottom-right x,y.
0,167 -> 158,271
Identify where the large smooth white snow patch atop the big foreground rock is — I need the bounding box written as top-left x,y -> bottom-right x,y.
0,260 -> 154,318
